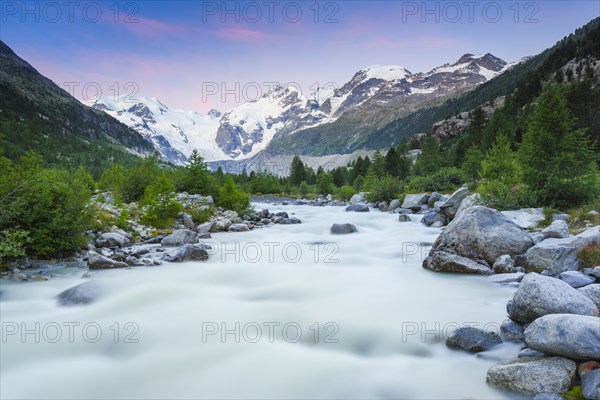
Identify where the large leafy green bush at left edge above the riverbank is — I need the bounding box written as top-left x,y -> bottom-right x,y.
0,153 -> 93,257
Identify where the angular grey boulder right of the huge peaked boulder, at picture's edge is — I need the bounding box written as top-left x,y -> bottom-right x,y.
523,226 -> 600,275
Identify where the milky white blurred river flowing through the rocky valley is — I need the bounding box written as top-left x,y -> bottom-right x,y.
0,205 -> 517,399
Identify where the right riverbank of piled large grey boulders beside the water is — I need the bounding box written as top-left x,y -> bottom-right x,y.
412,189 -> 600,400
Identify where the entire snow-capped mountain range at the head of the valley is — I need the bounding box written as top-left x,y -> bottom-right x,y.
84,53 -> 516,163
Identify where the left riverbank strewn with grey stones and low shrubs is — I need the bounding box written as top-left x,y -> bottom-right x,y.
2,193 -> 302,282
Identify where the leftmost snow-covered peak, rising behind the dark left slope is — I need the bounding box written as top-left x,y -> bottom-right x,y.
82,96 -> 227,164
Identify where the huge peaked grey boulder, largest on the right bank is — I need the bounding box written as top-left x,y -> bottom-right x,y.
429,206 -> 533,265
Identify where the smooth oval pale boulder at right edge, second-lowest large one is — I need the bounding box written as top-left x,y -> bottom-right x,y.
525,314 -> 600,360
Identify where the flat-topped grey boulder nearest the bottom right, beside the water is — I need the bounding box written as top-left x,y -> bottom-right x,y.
486,357 -> 576,394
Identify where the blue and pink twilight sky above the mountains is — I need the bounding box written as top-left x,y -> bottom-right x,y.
0,0 -> 600,113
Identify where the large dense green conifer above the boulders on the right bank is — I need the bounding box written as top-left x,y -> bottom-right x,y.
519,82 -> 599,207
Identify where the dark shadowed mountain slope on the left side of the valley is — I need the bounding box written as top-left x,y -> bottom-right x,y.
0,41 -> 154,169
